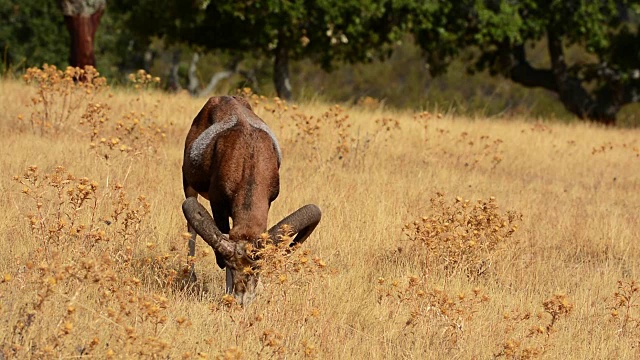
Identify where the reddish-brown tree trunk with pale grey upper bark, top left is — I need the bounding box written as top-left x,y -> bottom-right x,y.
60,0 -> 106,68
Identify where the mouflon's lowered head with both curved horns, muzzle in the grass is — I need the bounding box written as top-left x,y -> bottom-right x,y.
182,198 -> 322,304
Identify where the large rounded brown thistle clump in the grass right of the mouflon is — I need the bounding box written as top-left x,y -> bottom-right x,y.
403,193 -> 522,278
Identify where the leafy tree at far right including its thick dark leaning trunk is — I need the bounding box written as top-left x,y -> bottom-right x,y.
397,0 -> 640,123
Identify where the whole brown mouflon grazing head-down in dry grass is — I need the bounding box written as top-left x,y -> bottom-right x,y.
182,96 -> 321,304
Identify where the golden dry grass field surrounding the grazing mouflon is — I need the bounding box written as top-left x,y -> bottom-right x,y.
0,69 -> 640,360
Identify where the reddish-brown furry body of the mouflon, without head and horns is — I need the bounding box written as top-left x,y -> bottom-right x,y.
182,96 -> 280,267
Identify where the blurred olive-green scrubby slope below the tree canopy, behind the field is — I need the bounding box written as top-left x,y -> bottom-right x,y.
292,37 -> 568,121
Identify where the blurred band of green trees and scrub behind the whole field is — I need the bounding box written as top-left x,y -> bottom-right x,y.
0,0 -> 640,124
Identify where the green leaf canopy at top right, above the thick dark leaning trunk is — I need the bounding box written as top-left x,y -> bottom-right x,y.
404,0 -> 637,70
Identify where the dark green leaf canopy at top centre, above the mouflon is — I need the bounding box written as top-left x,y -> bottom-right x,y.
114,0 -> 402,68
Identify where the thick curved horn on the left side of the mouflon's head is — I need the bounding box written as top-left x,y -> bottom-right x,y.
182,197 -> 234,259
